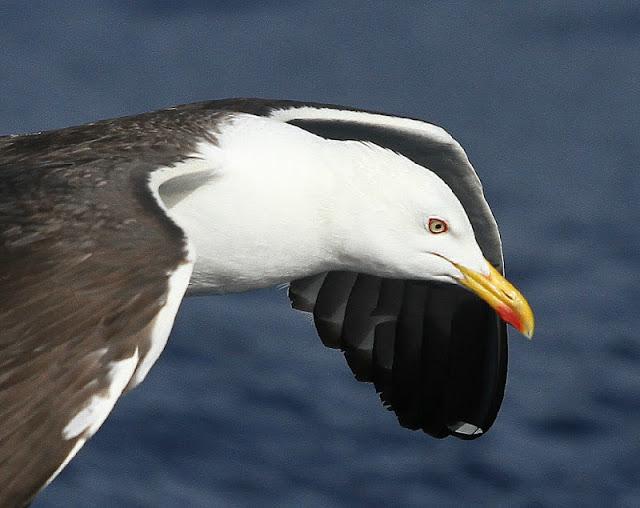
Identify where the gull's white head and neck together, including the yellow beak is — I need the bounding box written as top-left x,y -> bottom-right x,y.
161,115 -> 533,334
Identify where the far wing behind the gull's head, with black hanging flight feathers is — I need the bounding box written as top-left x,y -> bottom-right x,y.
273,103 -> 507,439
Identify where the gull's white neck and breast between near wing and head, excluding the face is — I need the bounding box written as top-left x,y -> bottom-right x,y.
151,114 -> 442,292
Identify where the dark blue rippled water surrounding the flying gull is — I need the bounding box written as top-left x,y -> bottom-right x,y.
0,0 -> 640,508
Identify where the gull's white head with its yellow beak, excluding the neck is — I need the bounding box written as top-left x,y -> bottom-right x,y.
342,145 -> 534,338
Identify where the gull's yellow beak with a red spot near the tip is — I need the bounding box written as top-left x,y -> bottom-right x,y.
452,262 -> 535,339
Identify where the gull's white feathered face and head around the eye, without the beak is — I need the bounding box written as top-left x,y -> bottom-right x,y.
332,143 -> 489,283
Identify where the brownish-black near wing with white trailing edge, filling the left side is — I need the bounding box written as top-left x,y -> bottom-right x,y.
0,111 -> 206,506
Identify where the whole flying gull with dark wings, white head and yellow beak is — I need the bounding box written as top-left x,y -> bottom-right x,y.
0,99 -> 534,506
